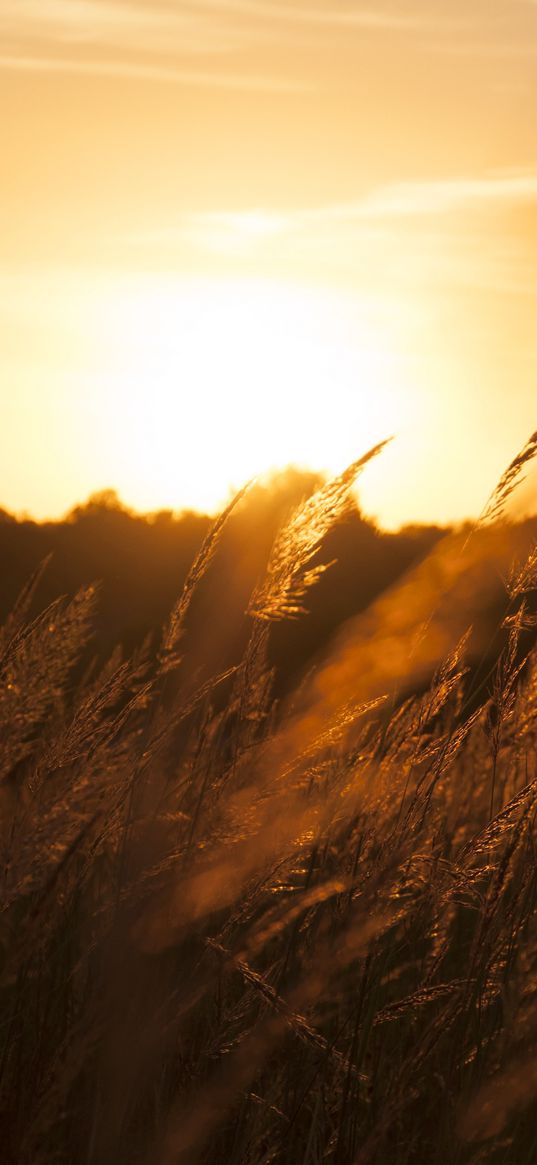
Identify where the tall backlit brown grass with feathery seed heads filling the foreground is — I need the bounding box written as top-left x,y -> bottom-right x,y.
0,443 -> 537,1165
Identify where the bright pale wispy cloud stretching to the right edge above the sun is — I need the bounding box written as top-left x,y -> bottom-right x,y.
122,171 -> 537,296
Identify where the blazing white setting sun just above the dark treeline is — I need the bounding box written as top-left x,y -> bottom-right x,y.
96,278 -> 401,511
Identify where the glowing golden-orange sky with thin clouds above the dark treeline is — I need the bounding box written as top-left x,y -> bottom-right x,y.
0,0 -> 537,527
